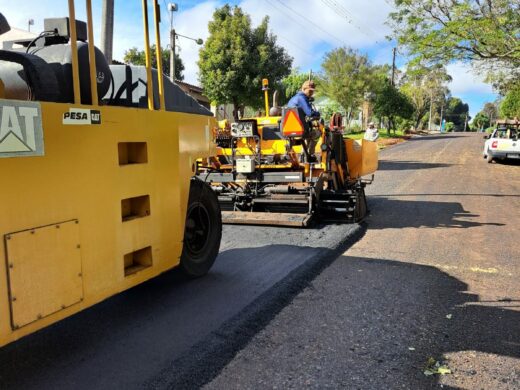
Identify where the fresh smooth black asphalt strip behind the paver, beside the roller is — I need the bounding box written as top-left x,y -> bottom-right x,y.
0,215 -> 362,390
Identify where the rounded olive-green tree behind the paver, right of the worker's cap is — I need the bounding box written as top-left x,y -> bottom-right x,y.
317,47 -> 388,126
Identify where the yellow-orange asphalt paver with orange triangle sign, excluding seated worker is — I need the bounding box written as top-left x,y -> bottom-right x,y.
197,80 -> 378,226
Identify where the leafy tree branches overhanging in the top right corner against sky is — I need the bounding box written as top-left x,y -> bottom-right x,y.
390,0 -> 520,75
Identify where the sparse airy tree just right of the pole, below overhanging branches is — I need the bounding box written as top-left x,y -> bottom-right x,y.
401,64 -> 451,129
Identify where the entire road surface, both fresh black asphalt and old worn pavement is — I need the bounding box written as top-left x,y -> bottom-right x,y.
0,134 -> 520,389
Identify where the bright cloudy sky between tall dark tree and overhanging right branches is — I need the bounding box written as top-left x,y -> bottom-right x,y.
240,0 -> 390,71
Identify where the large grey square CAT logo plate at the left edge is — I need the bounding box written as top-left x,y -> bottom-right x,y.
0,100 -> 44,158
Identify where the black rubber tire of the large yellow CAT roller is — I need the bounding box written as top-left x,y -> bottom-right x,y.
180,179 -> 222,278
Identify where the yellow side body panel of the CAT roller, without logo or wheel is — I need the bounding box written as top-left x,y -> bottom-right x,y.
0,99 -> 215,345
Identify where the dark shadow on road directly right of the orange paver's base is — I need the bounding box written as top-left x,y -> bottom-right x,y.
368,196 -> 505,229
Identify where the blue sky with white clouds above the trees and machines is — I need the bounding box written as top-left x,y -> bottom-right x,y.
0,0 -> 496,117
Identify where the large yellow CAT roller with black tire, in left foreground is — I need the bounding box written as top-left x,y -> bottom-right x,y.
0,0 -> 221,346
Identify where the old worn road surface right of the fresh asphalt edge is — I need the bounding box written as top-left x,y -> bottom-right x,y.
205,133 -> 520,389
